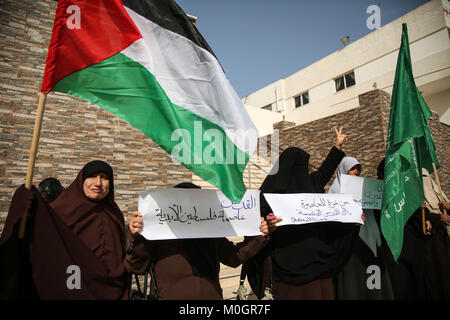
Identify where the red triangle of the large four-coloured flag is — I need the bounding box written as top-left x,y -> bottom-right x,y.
41,0 -> 142,93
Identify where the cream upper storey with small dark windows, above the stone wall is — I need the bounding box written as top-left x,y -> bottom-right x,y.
242,0 -> 450,129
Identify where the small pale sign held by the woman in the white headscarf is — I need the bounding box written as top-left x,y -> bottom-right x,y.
340,174 -> 383,210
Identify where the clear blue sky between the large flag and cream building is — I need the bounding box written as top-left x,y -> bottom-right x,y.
175,0 -> 428,98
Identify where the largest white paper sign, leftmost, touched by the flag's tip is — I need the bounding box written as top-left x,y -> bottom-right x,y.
138,188 -> 261,240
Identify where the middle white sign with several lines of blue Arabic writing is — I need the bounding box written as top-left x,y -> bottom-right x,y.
264,193 -> 363,226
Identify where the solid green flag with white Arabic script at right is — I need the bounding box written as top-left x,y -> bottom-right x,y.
381,24 -> 439,260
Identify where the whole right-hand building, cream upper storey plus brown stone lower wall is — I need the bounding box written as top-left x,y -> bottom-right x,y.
234,0 -> 450,298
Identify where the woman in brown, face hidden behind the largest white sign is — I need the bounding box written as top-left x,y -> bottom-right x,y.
125,182 -> 275,300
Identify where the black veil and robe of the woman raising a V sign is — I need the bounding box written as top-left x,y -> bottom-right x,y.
260,147 -> 354,285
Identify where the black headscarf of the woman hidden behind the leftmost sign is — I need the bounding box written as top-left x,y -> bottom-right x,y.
174,182 -> 219,278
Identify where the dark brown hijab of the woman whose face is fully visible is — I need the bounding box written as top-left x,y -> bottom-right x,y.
51,160 -> 125,276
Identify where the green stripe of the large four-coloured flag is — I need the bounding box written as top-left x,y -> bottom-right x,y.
53,53 -> 249,201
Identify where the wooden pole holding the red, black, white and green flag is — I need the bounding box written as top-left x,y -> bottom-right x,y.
19,92 -> 47,239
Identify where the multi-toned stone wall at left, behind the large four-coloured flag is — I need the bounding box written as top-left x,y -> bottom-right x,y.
0,0 -> 192,232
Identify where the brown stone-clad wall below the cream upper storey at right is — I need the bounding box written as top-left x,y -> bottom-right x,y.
267,89 -> 450,194
